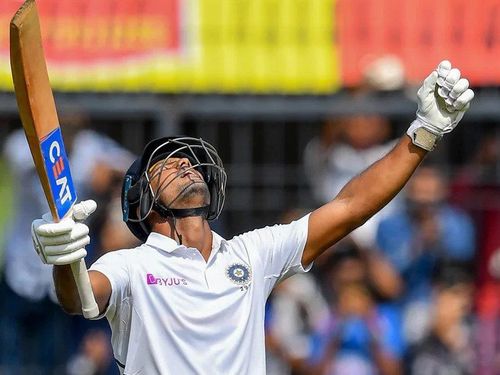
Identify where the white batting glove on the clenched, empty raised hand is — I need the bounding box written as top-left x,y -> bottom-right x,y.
407,60 -> 474,151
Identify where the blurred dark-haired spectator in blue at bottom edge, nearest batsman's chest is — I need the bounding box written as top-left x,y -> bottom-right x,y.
308,241 -> 404,375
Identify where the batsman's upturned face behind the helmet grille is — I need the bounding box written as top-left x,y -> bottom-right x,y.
148,157 -> 210,208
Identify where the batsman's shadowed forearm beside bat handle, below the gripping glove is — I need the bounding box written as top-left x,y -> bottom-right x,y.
53,265 -> 82,315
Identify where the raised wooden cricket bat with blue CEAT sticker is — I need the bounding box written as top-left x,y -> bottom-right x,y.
10,0 -> 99,318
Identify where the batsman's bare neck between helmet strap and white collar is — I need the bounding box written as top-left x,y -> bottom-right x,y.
152,216 -> 212,261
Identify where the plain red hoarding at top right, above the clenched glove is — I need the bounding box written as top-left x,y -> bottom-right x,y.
335,0 -> 500,86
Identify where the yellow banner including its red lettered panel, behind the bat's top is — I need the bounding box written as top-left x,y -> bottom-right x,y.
0,0 -> 340,94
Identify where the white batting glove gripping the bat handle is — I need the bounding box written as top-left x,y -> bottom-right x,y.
31,200 -> 97,266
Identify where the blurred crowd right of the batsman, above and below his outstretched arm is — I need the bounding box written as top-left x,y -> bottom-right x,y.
266,114 -> 500,375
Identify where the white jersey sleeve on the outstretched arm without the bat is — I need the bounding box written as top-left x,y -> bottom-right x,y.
243,215 -> 312,281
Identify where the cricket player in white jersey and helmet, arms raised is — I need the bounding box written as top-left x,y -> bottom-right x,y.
32,61 -> 474,375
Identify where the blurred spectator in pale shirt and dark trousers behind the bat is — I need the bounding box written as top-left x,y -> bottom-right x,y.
0,112 -> 133,375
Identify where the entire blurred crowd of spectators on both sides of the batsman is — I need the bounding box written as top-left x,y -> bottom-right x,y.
0,108 -> 500,375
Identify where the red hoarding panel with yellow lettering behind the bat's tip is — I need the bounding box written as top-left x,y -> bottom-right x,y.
0,0 -> 181,64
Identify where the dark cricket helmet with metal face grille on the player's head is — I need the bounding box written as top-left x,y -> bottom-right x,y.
122,136 -> 227,241
